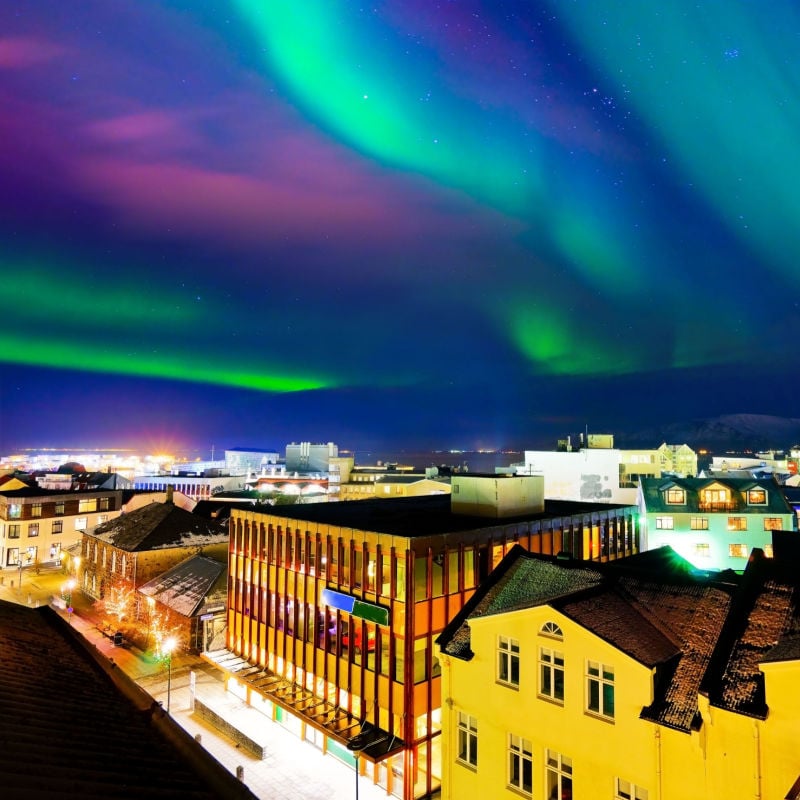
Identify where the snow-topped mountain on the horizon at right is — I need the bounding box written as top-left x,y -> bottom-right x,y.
614,414 -> 800,452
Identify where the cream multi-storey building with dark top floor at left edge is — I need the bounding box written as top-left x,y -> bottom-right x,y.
0,479 -> 123,570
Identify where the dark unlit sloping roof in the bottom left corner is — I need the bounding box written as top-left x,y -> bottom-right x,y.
0,601 -> 254,800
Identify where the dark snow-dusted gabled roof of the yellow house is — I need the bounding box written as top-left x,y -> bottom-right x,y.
437,546 -> 735,731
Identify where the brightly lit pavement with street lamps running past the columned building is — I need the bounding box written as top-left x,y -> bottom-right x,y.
0,568 -> 387,800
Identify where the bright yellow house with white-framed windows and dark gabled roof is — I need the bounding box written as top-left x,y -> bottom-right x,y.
437,548 -> 800,800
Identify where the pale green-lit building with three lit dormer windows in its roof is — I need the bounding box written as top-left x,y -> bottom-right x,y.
639,477 -> 797,572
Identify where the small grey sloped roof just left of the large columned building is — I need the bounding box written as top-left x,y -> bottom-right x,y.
139,556 -> 228,617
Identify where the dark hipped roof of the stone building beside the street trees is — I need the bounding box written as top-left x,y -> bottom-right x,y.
91,502 -> 228,552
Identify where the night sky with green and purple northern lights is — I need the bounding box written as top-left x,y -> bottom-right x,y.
0,0 -> 800,450
